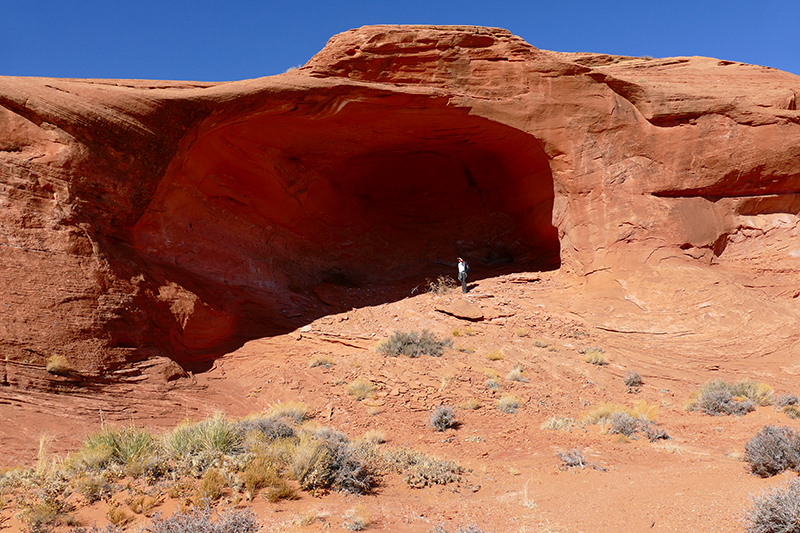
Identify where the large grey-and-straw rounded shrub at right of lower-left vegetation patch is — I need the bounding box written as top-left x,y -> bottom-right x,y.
290,430 -> 377,494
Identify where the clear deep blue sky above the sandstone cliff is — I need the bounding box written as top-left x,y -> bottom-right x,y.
0,0 -> 800,81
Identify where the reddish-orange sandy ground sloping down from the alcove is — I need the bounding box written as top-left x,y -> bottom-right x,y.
0,272 -> 800,533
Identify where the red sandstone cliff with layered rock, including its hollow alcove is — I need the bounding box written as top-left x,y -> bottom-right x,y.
0,26 -> 800,386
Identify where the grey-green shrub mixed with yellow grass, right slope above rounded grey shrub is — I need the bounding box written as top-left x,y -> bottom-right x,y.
686,379 -> 772,416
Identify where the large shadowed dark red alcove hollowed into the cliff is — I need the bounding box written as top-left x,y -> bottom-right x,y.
135,96 -> 560,362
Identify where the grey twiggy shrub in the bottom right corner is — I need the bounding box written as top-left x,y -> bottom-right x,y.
746,479 -> 800,533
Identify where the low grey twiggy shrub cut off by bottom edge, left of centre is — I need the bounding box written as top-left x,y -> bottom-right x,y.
147,508 -> 259,533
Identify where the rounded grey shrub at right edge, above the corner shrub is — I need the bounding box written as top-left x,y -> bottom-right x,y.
744,426 -> 800,477
